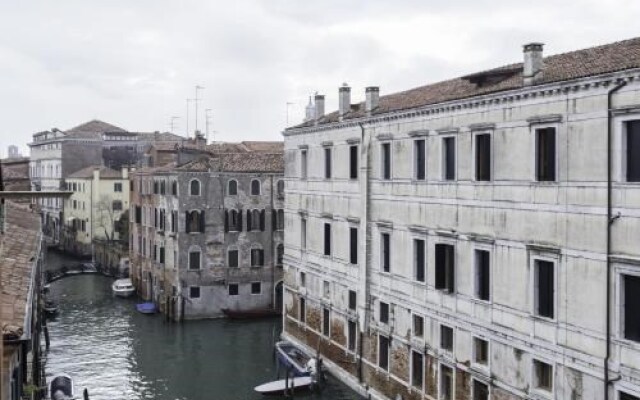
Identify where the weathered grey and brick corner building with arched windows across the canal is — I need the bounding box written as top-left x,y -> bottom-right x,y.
129,142 -> 284,320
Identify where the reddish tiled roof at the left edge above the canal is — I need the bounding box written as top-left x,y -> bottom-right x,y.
0,201 -> 40,339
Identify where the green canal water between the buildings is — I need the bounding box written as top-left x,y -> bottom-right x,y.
46,275 -> 359,400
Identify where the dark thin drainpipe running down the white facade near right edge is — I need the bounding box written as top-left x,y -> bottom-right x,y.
604,77 -> 627,400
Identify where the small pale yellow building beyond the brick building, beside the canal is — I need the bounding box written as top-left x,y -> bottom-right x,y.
62,166 -> 129,255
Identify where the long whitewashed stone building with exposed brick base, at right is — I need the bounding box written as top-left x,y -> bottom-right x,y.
284,38 -> 640,400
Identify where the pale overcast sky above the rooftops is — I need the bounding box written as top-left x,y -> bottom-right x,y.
0,0 -> 640,154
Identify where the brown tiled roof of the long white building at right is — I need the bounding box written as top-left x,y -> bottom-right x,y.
288,38 -> 640,129
